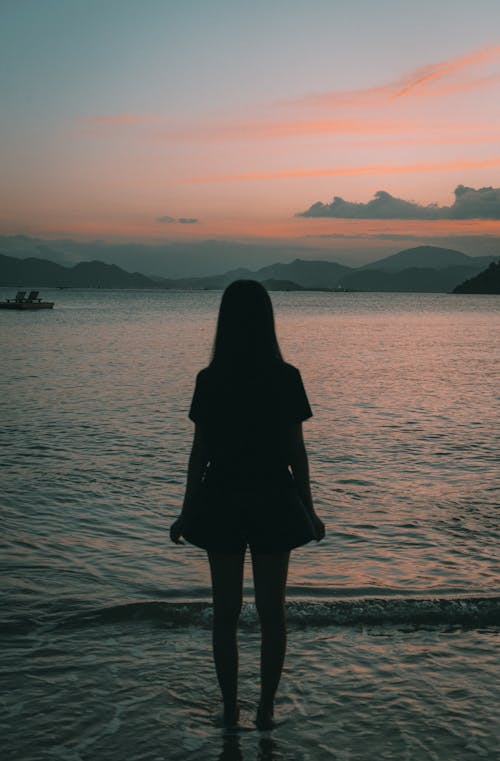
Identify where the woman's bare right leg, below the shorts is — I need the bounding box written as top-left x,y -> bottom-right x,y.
252,552 -> 290,728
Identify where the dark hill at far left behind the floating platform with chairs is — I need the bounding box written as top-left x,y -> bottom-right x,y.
0,254 -> 159,288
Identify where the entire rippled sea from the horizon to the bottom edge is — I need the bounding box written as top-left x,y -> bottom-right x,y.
0,289 -> 500,761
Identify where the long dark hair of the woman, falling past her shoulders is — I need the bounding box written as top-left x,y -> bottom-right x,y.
210,280 -> 283,372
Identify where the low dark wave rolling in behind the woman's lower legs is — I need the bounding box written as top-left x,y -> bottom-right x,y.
1,596 -> 500,634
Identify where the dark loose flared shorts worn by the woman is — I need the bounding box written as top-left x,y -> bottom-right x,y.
183,473 -> 315,554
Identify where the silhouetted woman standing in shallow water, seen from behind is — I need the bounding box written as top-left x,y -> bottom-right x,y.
170,280 -> 325,729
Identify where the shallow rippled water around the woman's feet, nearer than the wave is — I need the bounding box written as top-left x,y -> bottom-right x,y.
2,624 -> 500,761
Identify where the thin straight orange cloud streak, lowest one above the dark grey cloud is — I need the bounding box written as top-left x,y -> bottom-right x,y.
180,157 -> 500,184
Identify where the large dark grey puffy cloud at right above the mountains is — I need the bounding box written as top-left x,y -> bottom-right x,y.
295,185 -> 500,219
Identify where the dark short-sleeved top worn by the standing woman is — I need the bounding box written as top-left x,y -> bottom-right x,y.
189,362 -> 312,476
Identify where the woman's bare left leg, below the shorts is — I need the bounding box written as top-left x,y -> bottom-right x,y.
208,551 -> 245,725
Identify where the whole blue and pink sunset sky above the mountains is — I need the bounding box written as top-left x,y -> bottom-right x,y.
0,0 -> 500,262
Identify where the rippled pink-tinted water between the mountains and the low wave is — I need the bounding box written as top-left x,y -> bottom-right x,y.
0,291 -> 500,599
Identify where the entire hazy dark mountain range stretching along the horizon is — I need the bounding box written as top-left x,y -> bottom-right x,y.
0,246 -> 498,293
